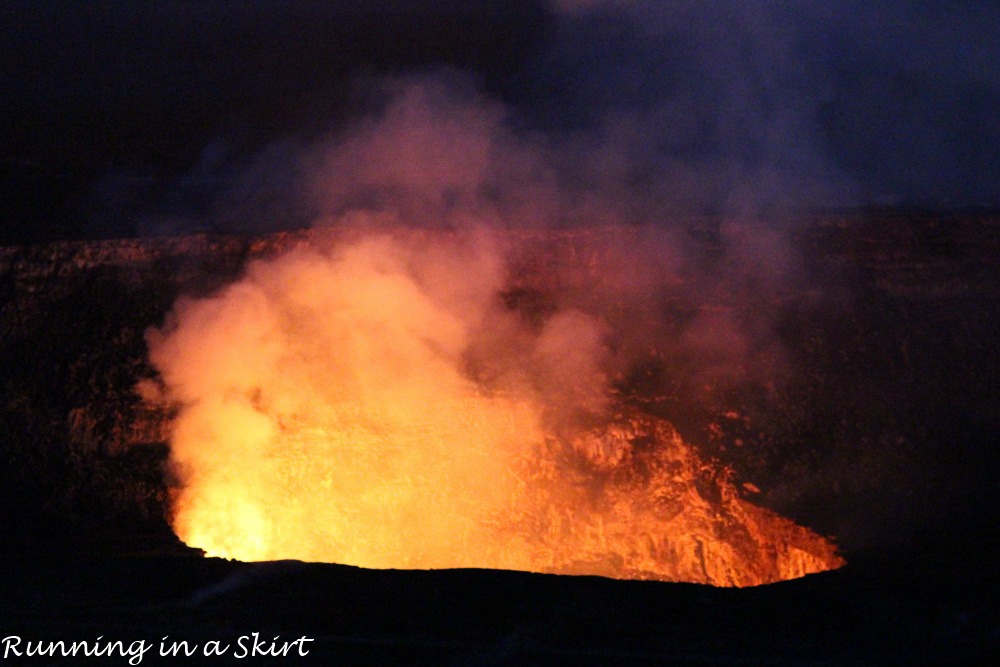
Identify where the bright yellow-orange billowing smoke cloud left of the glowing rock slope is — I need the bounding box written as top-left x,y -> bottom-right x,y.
144,223 -> 628,568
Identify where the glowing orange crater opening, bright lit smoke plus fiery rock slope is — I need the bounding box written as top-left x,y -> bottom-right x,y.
144,228 -> 842,586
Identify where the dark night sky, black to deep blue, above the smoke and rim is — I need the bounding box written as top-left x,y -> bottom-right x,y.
0,0 -> 1000,242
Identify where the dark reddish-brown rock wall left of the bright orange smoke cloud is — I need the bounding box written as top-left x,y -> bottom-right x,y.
0,239 -> 254,542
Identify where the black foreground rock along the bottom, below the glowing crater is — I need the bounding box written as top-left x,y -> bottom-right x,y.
0,544 -> 1000,665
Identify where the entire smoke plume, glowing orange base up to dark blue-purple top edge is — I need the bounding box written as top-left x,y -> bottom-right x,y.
135,2 -> 892,576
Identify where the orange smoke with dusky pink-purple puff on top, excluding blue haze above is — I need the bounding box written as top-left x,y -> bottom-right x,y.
143,58 -> 812,576
